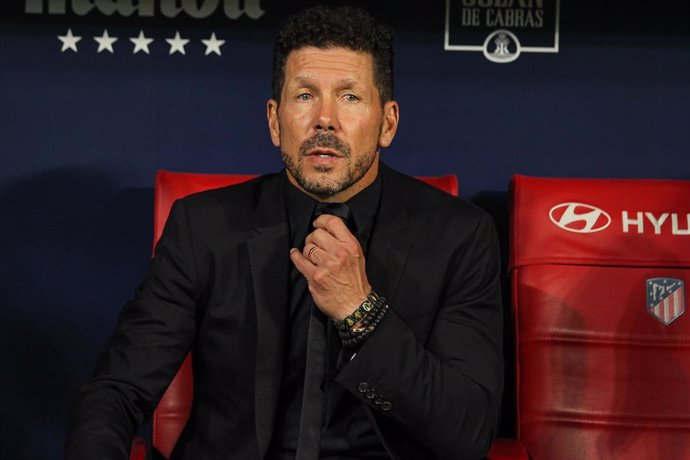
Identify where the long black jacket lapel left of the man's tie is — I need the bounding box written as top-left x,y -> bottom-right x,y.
247,174 -> 290,458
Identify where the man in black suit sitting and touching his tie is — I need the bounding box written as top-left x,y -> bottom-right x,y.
66,7 -> 502,460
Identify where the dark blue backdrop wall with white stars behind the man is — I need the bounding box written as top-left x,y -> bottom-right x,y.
0,0 -> 690,460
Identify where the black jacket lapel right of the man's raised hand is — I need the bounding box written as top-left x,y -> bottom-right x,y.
367,164 -> 410,304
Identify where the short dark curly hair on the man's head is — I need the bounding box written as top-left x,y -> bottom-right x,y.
272,5 -> 393,104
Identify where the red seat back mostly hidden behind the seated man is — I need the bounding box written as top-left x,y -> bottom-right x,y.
152,171 -> 458,459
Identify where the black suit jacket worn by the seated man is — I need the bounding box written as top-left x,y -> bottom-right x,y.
66,165 -> 503,460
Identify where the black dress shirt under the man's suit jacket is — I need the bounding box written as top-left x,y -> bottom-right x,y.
267,173 -> 389,460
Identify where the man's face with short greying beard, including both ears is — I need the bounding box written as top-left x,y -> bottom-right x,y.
268,47 -> 398,201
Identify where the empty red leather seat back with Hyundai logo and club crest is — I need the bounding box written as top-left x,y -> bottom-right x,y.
510,176 -> 690,460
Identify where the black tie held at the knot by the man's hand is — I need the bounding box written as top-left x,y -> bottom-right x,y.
295,203 -> 357,460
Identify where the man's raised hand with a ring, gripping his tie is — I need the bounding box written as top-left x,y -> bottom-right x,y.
290,214 -> 371,320
